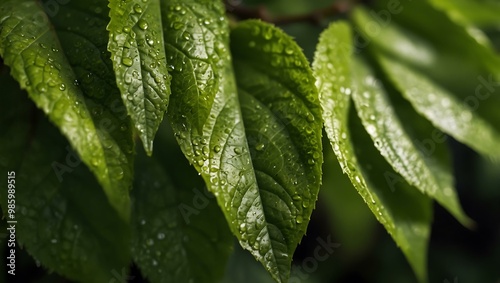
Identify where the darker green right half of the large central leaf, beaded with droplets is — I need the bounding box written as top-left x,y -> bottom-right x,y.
231,21 -> 323,281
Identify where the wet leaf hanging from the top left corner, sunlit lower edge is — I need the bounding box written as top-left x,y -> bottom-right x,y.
0,0 -> 133,222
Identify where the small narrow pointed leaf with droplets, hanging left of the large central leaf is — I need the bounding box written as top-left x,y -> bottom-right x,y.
107,0 -> 170,155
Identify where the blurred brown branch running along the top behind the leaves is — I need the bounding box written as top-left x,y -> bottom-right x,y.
224,0 -> 356,25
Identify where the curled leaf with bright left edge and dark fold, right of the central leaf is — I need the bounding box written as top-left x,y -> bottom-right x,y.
313,22 -> 431,281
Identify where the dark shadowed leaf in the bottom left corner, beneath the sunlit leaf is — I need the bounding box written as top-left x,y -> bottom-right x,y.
0,75 -> 130,283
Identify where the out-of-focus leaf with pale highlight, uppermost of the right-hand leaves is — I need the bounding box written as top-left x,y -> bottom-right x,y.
353,5 -> 500,136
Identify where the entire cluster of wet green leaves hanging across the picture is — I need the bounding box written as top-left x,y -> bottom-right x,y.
0,0 -> 500,282
